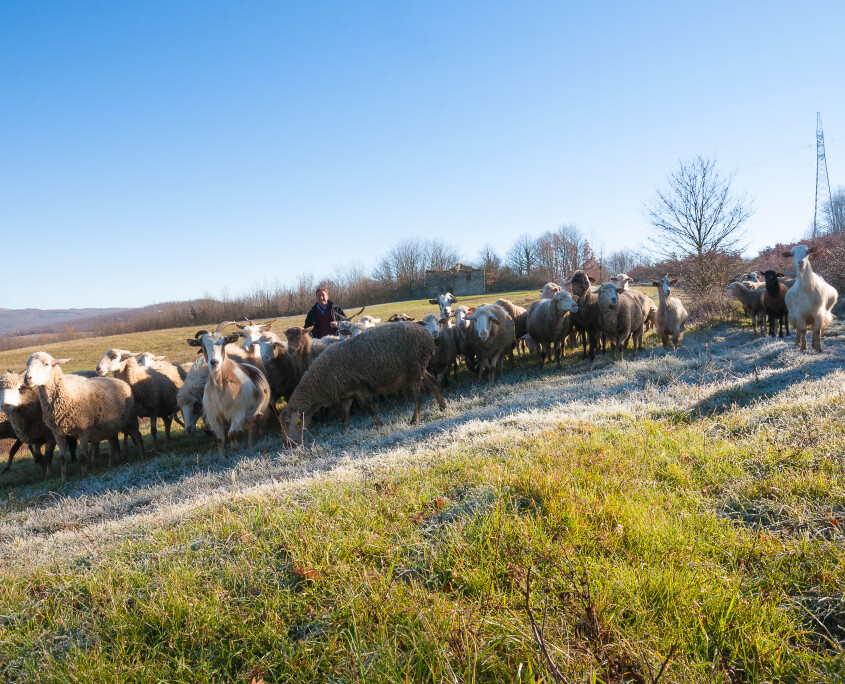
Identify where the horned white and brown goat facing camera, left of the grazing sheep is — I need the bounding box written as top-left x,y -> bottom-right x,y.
188,322 -> 270,458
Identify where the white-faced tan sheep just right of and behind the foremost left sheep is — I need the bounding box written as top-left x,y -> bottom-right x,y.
96,349 -> 186,451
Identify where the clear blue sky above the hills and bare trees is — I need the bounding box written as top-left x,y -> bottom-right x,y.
0,0 -> 845,308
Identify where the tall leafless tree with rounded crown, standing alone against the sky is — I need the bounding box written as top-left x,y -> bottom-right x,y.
645,156 -> 754,290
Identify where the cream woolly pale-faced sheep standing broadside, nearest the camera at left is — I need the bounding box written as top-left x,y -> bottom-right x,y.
24,352 -> 146,480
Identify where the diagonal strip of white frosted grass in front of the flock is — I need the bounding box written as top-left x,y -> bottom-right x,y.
0,323 -> 845,569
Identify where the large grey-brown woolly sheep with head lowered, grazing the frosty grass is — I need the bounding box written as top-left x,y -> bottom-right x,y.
279,323 -> 446,441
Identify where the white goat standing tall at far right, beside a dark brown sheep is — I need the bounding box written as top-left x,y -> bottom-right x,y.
783,245 -> 838,351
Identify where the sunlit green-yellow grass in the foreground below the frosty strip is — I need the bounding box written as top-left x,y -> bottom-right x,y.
0,400 -> 845,682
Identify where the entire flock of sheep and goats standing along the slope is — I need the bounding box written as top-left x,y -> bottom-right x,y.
0,245 -> 837,479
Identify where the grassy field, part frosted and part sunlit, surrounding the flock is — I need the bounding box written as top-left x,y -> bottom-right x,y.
0,293 -> 845,684
